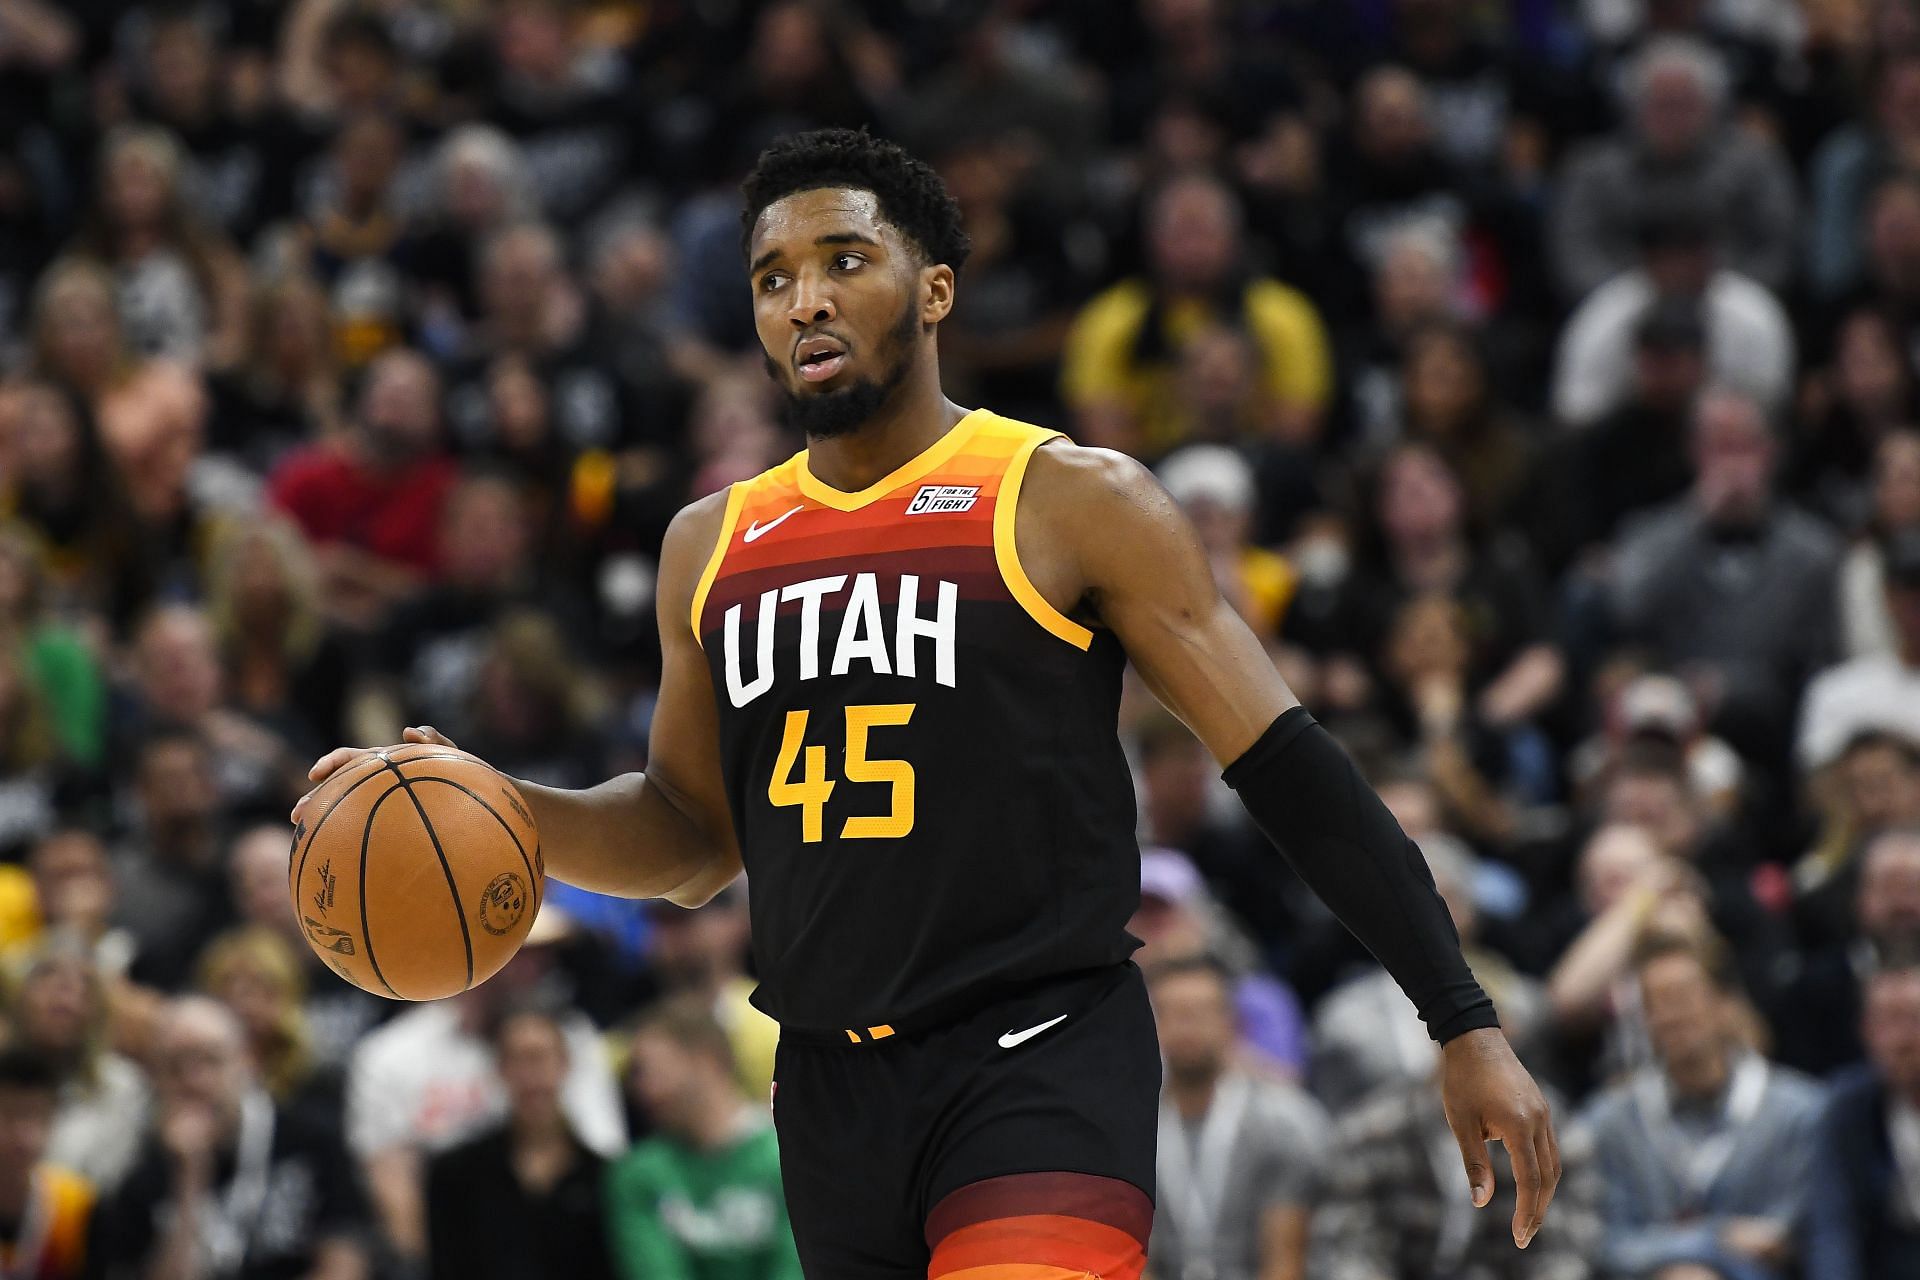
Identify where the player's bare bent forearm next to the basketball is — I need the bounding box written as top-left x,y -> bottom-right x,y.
516,773 -> 739,906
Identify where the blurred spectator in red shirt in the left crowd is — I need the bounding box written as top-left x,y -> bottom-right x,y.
271,351 -> 457,629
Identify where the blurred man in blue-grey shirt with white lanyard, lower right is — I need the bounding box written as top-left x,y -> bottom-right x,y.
1586,936 -> 1837,1280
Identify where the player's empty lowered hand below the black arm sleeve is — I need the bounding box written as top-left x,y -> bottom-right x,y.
1440,1027 -> 1561,1249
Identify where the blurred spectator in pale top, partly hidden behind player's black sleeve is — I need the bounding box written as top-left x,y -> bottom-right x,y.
1311,833 -> 1548,1115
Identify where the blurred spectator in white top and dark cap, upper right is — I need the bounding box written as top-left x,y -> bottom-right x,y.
1553,205 -> 1793,426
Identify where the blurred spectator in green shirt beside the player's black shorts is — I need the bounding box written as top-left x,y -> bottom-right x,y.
607,1000 -> 801,1280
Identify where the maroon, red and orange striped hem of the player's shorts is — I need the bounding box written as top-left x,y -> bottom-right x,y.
927,1173 -> 1152,1280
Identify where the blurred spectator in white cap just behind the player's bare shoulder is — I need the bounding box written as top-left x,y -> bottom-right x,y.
1160,445 -> 1298,645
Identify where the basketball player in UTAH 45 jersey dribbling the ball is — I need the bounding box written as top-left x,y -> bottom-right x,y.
296,130 -> 1559,1280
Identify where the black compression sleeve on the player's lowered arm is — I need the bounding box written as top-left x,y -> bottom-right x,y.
1225,706 -> 1500,1044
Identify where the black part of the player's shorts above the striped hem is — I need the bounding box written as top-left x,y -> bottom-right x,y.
774,961 -> 1160,1280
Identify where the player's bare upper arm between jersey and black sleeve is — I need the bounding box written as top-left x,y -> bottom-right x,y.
1043,449 -> 1296,764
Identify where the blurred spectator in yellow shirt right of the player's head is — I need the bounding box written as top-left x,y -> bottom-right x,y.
1062,173 -> 1332,457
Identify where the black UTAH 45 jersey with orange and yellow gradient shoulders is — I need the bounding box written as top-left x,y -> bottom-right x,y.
693,409 -> 1139,1040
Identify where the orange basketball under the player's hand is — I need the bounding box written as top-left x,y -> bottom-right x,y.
288,745 -> 545,1000
